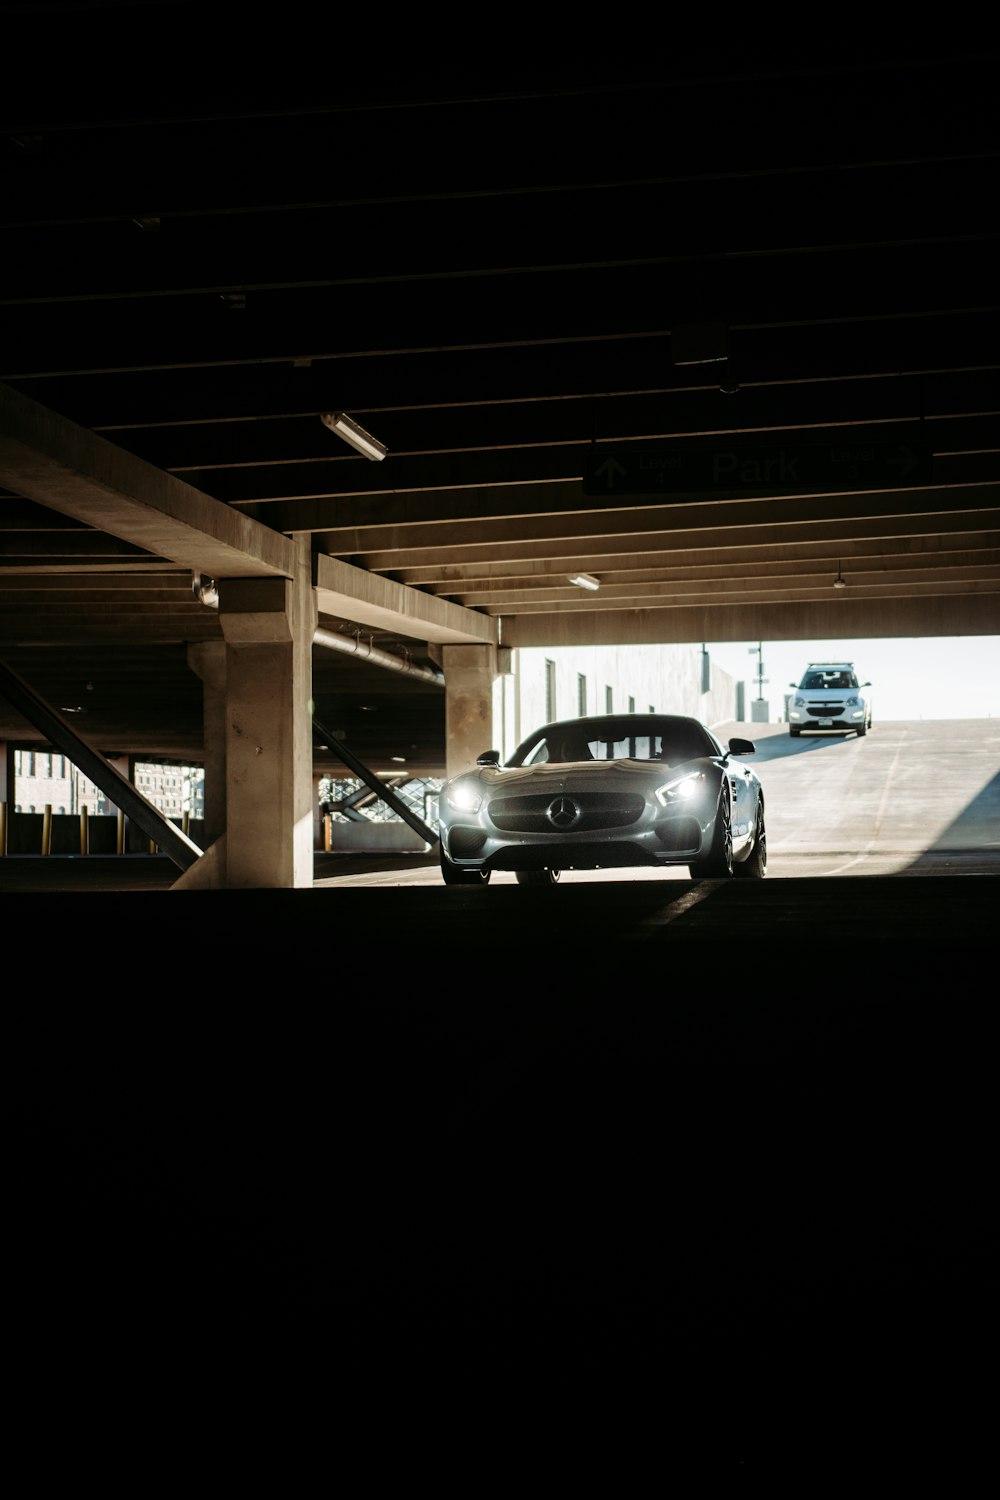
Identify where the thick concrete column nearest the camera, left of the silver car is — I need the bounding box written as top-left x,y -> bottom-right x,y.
219,536 -> 318,888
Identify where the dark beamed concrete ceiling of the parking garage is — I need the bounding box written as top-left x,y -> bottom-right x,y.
0,14 -> 1000,770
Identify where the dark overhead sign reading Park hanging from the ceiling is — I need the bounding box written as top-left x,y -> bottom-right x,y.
583,440 -> 933,497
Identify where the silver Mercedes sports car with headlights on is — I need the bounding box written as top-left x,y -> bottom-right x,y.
438,714 -> 768,885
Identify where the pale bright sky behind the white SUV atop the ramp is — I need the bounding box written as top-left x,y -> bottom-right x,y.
706,636 -> 1000,725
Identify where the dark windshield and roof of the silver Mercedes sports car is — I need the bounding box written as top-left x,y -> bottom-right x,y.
508,716 -> 724,765
